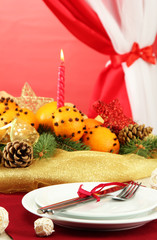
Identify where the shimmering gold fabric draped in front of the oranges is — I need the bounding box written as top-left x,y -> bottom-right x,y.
0,151 -> 157,193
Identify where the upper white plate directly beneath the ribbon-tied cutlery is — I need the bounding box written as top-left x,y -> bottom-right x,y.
35,182 -> 157,219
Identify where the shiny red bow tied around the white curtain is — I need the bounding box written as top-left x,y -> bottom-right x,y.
111,42 -> 156,67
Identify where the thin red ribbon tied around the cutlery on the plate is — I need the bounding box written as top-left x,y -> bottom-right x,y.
77,182 -> 126,201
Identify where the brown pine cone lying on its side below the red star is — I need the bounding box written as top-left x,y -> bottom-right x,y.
118,124 -> 153,144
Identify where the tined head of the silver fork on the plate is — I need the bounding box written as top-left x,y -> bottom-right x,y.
112,181 -> 142,201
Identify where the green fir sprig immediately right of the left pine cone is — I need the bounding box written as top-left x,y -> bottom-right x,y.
33,132 -> 56,158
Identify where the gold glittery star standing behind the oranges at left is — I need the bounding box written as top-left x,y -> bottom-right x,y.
15,82 -> 54,113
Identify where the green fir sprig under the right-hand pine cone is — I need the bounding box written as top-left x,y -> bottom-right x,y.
119,136 -> 157,158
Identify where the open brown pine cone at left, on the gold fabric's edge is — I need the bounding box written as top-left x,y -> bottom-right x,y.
2,141 -> 33,168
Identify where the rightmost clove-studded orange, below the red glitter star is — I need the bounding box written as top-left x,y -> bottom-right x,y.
82,126 -> 120,153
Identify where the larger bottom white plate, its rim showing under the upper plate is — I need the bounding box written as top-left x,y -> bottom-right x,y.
22,183 -> 157,231
